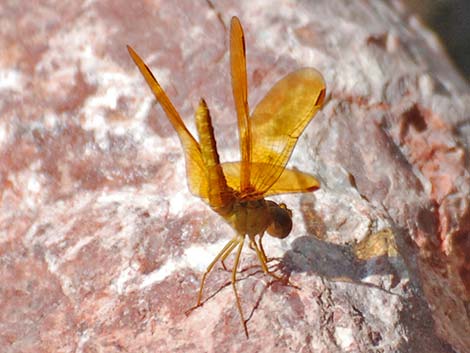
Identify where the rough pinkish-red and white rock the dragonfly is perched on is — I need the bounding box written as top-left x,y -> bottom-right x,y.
0,0 -> 470,352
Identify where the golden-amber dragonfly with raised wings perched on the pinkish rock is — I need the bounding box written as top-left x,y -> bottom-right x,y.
127,16 -> 326,338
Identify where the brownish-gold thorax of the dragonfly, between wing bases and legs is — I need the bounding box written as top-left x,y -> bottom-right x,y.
226,199 -> 272,236
